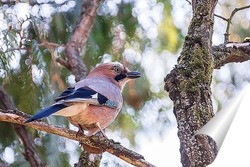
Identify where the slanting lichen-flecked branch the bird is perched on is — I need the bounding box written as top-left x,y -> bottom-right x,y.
0,109 -> 154,167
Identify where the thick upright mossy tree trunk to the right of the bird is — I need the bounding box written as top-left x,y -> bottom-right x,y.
165,0 -> 218,167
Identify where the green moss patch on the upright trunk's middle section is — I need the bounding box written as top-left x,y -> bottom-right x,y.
179,42 -> 213,92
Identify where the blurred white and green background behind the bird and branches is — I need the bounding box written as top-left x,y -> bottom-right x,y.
0,0 -> 250,167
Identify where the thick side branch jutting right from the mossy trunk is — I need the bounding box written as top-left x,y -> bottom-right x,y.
212,42 -> 250,69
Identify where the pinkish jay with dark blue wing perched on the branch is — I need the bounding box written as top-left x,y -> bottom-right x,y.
25,62 -> 141,136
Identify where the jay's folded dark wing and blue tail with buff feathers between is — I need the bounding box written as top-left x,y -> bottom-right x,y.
26,87 -> 119,122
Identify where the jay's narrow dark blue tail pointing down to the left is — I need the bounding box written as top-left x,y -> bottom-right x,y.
25,104 -> 66,123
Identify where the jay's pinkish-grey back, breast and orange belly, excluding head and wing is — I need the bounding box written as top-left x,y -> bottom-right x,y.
67,78 -> 123,136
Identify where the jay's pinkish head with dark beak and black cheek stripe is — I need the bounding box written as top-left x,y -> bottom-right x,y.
87,62 -> 141,90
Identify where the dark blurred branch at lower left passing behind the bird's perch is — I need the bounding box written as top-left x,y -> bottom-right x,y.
0,86 -> 44,167
